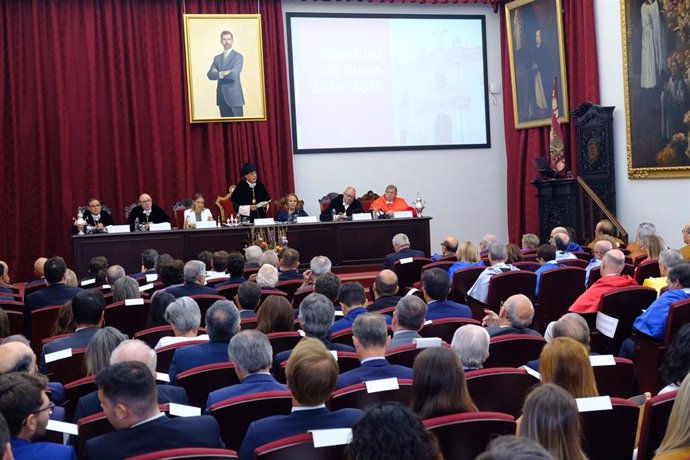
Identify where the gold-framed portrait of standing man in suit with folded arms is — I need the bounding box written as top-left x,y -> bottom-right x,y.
184,14 -> 266,123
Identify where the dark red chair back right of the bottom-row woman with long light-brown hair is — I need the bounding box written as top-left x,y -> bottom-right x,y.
580,398 -> 640,460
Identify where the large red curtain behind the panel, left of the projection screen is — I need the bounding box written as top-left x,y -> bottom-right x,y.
0,0 -> 293,279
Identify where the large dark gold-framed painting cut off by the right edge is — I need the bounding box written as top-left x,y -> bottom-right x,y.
621,0 -> 690,179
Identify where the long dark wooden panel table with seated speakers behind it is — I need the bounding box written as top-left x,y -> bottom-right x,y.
72,217 -> 431,277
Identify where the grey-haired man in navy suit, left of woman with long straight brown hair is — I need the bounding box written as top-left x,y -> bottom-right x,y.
271,292 -> 355,377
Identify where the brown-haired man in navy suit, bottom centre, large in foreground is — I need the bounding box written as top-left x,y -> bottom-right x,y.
240,336 -> 362,460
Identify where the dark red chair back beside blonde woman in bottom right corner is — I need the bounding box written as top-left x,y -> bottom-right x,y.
637,390 -> 678,460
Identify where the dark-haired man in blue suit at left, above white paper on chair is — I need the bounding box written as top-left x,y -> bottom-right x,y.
41,289 -> 105,374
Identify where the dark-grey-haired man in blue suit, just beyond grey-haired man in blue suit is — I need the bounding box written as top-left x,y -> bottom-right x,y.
168,300 -> 240,383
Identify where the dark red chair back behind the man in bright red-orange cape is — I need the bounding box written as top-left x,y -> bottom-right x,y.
591,286 -> 656,355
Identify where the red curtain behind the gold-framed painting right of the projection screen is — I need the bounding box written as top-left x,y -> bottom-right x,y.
501,0 -> 599,243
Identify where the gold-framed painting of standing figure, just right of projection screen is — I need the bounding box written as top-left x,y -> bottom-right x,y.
505,0 -> 568,129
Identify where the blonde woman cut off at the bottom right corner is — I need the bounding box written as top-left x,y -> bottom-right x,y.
654,374 -> 690,460
